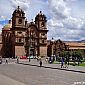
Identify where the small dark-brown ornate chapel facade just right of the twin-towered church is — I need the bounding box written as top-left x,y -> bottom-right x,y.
47,39 -> 68,57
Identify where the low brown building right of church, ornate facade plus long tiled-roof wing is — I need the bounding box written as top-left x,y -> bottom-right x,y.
47,39 -> 85,58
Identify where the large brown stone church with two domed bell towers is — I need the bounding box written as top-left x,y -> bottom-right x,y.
2,6 -> 48,58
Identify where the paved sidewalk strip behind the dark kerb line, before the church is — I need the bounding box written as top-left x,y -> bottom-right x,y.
19,59 -> 85,73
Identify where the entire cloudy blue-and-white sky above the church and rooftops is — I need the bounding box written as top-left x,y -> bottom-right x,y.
0,0 -> 85,41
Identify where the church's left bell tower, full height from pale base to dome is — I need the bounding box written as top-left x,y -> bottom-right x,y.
11,6 -> 27,56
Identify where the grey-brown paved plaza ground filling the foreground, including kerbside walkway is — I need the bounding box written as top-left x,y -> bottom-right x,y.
0,60 -> 85,85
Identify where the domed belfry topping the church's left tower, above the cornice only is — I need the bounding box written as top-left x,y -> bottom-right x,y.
12,6 -> 25,28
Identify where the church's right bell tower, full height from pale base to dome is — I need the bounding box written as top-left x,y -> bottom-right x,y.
35,11 -> 48,56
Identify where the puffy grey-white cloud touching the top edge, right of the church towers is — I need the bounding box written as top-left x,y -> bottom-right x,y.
48,0 -> 70,19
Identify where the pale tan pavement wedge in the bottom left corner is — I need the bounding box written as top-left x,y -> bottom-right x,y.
0,74 -> 25,85
